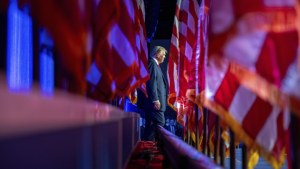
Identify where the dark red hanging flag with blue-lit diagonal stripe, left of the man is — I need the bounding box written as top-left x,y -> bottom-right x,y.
87,0 -> 139,100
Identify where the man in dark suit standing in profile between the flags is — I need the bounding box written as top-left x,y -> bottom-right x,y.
144,46 -> 167,141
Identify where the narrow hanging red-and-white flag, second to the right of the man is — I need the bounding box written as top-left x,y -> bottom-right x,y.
185,0 -> 210,143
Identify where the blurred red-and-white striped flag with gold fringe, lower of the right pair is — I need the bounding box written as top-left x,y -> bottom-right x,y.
205,57 -> 289,168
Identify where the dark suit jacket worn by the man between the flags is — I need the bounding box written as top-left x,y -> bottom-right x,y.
147,58 -> 167,111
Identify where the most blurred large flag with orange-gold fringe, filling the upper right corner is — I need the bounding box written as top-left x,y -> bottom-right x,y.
207,0 -> 300,115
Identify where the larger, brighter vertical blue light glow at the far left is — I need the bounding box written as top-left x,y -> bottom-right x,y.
7,0 -> 33,91
